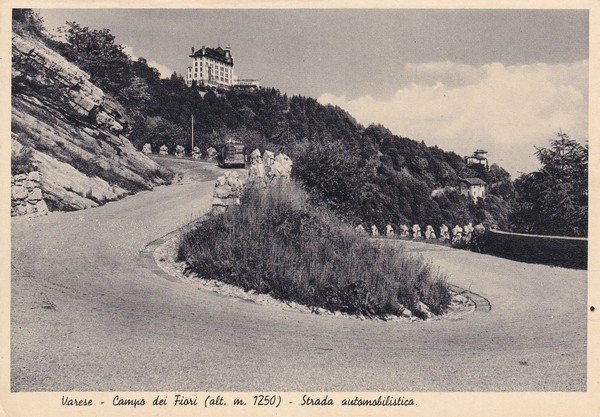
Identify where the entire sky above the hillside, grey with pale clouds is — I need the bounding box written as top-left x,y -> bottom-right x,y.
40,9 -> 589,176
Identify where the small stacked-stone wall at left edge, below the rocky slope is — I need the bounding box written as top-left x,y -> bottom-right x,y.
10,171 -> 48,216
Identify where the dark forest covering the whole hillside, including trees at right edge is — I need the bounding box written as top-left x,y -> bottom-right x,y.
15,12 -> 587,235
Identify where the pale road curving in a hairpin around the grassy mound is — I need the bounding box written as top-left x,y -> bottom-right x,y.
11,158 -> 587,391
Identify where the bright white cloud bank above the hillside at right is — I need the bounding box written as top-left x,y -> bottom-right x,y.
318,61 -> 588,175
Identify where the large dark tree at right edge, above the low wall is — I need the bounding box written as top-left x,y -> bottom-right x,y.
511,132 -> 588,236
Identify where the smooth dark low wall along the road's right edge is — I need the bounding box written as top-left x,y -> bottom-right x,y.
481,230 -> 588,269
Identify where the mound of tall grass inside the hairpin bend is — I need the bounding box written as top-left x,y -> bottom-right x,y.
178,182 -> 450,317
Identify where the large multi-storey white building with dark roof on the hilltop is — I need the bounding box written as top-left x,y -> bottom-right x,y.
185,45 -> 260,89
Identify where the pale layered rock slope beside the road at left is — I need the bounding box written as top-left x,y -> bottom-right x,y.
12,30 -> 171,210
